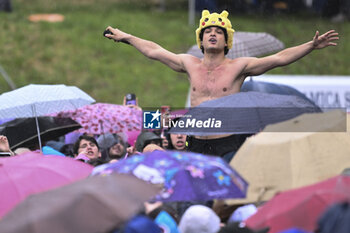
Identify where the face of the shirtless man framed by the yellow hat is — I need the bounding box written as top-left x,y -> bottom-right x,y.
202,27 -> 227,50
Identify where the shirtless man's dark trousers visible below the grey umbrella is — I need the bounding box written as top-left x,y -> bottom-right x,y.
187,134 -> 251,162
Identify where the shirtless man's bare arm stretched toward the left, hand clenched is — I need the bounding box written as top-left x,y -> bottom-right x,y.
105,26 -> 186,72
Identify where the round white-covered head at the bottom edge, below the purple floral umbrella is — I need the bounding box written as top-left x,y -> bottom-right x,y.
179,205 -> 220,233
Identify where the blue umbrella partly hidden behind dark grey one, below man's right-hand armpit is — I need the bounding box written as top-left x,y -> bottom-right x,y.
241,78 -> 317,106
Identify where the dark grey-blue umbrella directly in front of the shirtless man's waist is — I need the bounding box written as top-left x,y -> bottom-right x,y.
170,91 -> 321,136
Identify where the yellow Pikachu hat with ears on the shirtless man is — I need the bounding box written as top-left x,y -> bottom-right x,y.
196,10 -> 235,49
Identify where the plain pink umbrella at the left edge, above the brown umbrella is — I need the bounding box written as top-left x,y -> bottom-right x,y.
0,152 -> 92,218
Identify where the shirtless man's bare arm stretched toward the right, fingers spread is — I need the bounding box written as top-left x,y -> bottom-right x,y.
243,30 -> 339,76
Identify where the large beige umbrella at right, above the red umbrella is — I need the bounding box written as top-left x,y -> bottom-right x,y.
227,110 -> 350,204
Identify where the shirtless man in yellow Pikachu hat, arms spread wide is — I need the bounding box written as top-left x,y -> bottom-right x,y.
106,10 -> 339,160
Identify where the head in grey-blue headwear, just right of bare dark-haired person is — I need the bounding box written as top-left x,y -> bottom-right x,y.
97,133 -> 127,159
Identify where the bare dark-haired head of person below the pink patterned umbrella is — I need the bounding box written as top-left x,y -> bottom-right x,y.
73,135 -> 101,159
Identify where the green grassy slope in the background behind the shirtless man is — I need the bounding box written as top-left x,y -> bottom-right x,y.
0,0 -> 350,107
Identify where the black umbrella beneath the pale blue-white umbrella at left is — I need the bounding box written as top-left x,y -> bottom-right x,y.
0,117 -> 81,150
